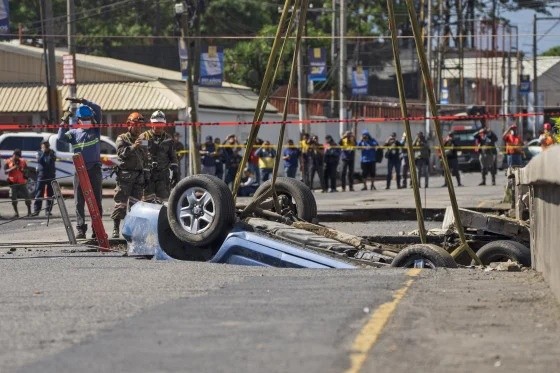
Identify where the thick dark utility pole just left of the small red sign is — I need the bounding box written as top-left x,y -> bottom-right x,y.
41,0 -> 59,123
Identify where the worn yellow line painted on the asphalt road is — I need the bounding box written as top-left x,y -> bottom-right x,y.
346,268 -> 421,373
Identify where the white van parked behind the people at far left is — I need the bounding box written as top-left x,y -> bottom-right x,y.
0,132 -> 118,193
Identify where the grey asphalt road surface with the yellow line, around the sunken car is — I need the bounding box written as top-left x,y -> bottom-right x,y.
0,171 -> 560,372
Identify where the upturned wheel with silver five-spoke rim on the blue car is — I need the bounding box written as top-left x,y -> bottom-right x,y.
167,175 -> 235,247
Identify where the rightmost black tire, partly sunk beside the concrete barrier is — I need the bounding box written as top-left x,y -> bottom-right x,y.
476,240 -> 531,267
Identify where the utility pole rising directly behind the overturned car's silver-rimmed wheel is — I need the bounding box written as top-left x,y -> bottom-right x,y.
175,1 -> 200,175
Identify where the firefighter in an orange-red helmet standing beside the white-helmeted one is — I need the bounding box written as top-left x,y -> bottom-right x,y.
111,112 -> 150,238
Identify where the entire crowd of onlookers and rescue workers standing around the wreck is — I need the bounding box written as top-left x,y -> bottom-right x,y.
4,98 -> 556,238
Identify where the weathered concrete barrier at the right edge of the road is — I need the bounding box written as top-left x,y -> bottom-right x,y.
516,145 -> 560,299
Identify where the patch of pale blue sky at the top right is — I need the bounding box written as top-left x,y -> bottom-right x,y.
501,8 -> 560,56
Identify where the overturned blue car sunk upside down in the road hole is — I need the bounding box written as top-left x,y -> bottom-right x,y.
122,175 -> 530,268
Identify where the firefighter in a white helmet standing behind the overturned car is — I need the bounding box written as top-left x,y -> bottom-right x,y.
138,110 -> 179,203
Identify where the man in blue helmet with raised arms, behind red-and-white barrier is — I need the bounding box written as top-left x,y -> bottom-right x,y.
58,97 -> 103,238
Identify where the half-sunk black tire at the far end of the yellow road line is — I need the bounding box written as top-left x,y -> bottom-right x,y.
391,244 -> 457,269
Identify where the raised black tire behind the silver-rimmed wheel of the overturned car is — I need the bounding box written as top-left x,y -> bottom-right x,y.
253,177 -> 317,222
